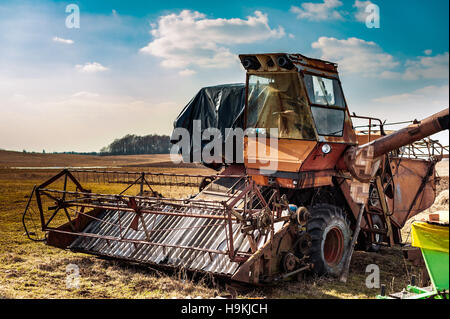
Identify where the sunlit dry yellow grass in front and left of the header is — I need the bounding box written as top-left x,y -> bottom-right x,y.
0,174 -> 223,298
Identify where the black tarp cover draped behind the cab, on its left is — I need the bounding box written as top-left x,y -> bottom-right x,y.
171,83 -> 245,166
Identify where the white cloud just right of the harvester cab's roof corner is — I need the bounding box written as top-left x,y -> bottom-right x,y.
312,37 -> 399,77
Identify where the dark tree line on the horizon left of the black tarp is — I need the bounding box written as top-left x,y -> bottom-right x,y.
100,134 -> 171,155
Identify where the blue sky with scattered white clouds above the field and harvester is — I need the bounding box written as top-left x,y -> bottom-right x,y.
0,0 -> 449,152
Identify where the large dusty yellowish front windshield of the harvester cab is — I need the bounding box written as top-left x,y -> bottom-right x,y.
247,73 -> 316,140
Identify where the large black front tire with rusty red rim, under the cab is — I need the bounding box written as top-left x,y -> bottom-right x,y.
306,204 -> 351,276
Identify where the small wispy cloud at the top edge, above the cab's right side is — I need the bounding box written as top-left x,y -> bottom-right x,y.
290,0 -> 343,21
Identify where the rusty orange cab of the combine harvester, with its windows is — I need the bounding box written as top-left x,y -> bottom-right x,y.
240,54 -> 357,187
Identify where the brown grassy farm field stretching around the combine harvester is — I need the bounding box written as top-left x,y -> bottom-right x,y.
0,151 -> 448,299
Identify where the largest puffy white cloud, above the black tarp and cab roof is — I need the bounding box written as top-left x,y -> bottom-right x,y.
140,10 -> 285,68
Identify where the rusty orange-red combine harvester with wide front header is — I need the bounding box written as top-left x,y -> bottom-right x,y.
23,54 -> 449,284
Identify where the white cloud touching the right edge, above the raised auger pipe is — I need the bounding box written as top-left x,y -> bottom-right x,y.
402,50 -> 449,80
